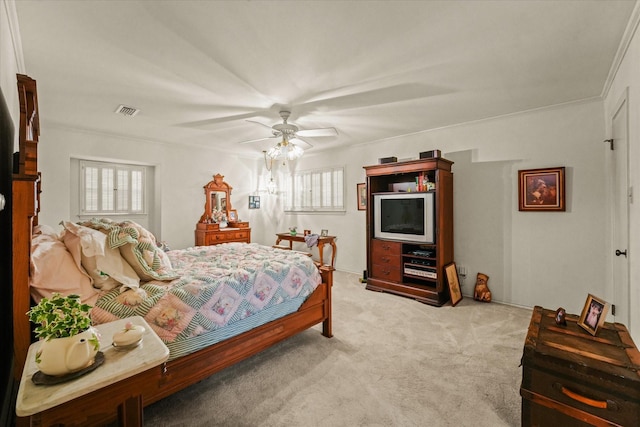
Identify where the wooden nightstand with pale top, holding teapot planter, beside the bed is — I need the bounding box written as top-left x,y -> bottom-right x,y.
16,316 -> 169,426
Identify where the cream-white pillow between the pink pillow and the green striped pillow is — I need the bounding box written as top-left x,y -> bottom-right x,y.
62,221 -> 140,290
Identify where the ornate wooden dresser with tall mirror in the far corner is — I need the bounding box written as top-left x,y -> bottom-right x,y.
195,174 -> 251,246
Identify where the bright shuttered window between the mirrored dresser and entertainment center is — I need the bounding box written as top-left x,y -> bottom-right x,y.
285,167 -> 345,212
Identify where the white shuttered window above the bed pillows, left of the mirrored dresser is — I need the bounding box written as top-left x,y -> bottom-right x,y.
79,160 -> 146,215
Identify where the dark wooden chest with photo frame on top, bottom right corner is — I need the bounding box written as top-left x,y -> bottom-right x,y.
520,307 -> 640,427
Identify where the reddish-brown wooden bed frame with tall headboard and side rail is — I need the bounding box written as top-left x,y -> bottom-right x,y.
12,75 -> 333,425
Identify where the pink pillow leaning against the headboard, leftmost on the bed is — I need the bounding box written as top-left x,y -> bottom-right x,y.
30,234 -> 98,304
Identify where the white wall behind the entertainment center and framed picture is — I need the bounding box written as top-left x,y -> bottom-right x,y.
288,100 -> 606,313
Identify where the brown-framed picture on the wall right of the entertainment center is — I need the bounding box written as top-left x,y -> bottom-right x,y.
518,167 -> 565,212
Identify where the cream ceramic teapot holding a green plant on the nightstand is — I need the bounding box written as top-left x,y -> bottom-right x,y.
36,328 -> 99,376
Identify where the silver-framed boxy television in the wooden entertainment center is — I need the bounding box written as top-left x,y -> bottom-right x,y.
373,193 -> 435,243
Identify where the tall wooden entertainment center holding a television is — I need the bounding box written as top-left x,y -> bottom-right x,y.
364,158 -> 453,306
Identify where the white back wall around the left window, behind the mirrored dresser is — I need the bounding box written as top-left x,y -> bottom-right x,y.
38,125 -> 256,249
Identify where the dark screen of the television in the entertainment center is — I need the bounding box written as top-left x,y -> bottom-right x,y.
380,198 -> 425,236
